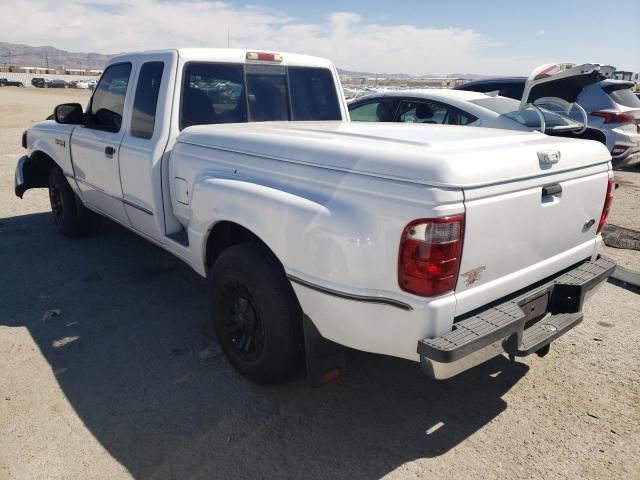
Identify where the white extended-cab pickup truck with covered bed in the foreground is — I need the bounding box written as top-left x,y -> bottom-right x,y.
15,49 -> 614,385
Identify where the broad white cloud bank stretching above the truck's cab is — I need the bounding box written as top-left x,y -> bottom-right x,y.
0,0 -> 544,74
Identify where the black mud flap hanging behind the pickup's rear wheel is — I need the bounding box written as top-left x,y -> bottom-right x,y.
303,315 -> 347,387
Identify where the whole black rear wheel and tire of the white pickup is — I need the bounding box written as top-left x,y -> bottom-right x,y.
209,242 -> 302,385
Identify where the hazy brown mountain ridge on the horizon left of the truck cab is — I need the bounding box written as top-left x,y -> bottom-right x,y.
0,42 -> 111,69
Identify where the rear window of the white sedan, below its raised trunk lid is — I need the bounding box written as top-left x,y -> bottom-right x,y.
470,97 -> 581,130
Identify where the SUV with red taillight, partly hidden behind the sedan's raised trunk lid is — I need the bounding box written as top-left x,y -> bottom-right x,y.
456,68 -> 640,168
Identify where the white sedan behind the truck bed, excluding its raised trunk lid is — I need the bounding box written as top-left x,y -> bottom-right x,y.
349,89 -> 581,133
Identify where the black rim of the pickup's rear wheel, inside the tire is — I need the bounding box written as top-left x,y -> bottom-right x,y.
222,278 -> 264,361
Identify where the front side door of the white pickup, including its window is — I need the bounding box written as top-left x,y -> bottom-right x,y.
71,63 -> 131,225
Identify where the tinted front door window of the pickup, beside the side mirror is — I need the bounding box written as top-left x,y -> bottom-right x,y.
87,63 -> 131,132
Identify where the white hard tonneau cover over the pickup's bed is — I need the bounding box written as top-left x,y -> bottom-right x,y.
177,122 -> 611,188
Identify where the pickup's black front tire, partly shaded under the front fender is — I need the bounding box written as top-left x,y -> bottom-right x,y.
49,167 -> 102,238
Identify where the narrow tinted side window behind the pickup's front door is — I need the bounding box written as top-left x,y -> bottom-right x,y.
131,62 -> 164,138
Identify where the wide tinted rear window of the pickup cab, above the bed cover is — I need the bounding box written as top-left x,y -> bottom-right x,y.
180,62 -> 342,129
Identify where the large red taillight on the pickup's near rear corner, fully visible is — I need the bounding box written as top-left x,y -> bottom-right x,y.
398,215 -> 464,297
